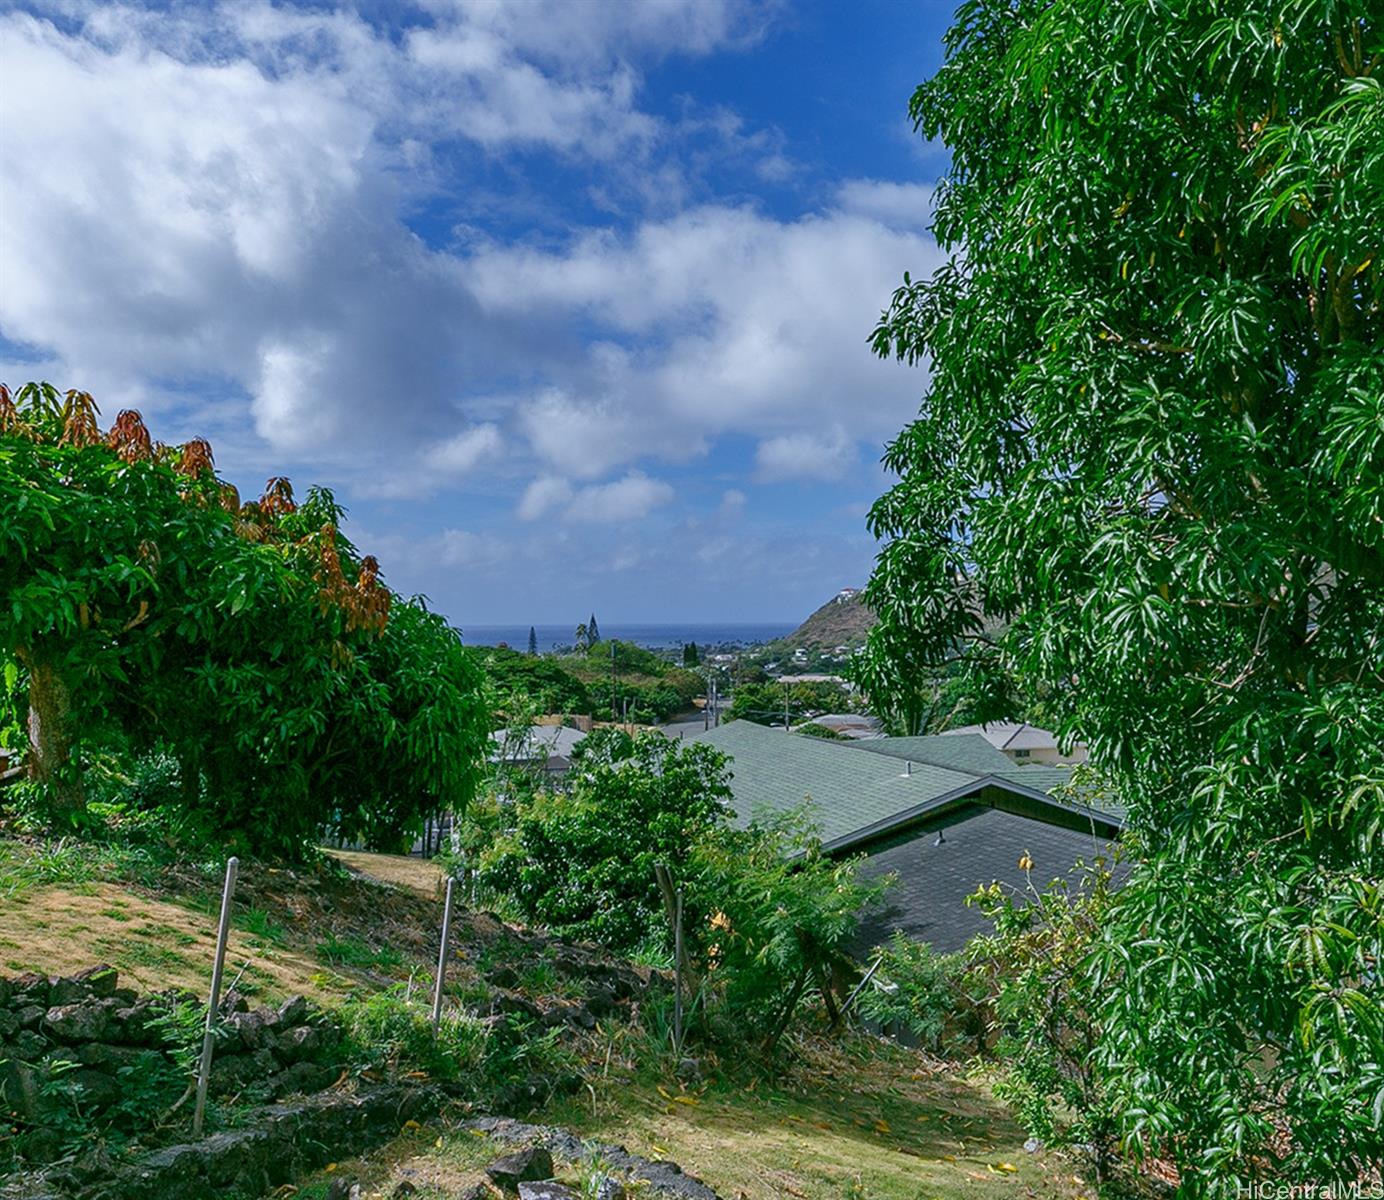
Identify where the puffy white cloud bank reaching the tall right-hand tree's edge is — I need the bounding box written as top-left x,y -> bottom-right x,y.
469,206 -> 940,475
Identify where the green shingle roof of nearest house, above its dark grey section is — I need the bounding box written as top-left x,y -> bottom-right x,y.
695,721 -> 1122,851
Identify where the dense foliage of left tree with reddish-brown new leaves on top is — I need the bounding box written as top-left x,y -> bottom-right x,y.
0,385 -> 486,851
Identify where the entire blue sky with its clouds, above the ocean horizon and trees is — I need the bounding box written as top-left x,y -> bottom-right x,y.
0,0 -> 951,626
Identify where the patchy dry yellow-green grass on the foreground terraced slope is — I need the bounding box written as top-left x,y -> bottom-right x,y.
0,842 -> 1091,1200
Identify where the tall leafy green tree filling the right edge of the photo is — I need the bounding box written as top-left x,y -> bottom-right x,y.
868,0 -> 1384,1194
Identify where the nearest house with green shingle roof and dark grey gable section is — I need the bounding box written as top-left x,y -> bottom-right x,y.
695,721 -> 1124,952
